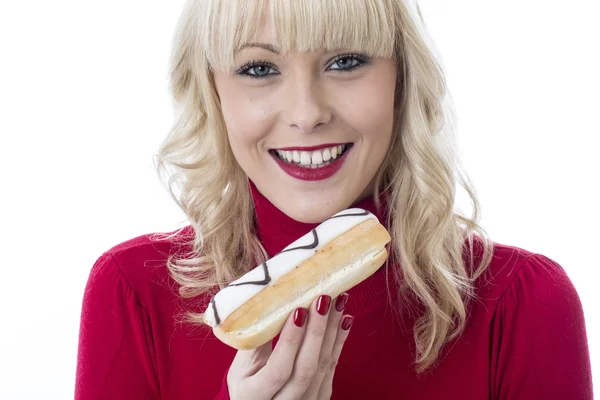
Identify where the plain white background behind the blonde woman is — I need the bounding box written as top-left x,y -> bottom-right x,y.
0,0 -> 600,399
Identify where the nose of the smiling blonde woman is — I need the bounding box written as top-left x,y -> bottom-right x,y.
287,79 -> 331,133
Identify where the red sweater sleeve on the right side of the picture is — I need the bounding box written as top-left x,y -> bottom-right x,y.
491,254 -> 593,400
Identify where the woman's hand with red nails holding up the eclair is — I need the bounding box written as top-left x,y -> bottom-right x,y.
227,293 -> 353,400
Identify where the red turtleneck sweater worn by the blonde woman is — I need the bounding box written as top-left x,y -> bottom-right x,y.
75,185 -> 592,400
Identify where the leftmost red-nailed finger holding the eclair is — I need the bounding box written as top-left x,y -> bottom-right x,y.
249,308 -> 308,399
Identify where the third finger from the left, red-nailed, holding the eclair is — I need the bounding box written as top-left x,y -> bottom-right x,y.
305,293 -> 349,399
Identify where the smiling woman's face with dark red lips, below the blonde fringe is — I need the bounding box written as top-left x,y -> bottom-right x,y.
214,18 -> 396,222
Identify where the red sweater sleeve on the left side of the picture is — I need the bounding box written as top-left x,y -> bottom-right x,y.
75,254 -> 160,400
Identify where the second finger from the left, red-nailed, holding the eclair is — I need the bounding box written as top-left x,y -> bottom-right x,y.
275,295 -> 331,399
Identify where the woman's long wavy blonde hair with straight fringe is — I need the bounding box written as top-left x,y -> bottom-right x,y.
157,0 -> 493,371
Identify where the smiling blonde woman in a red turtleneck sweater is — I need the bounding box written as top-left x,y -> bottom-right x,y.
76,0 -> 592,399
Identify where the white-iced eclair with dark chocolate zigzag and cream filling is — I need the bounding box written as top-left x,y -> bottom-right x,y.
204,208 -> 391,350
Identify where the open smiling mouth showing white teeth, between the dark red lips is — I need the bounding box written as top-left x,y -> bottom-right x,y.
269,143 -> 353,169
